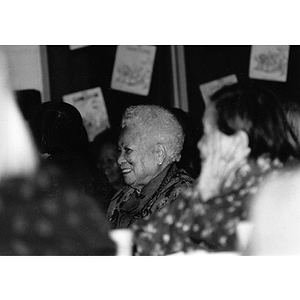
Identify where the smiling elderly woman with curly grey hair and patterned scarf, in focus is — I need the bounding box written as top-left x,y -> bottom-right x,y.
107,105 -> 193,229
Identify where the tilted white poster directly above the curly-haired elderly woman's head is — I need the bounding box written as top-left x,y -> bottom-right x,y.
111,46 -> 156,96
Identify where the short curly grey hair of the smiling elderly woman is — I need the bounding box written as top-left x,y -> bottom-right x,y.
121,105 -> 185,161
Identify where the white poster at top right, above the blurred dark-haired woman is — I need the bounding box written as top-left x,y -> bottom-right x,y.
249,46 -> 290,81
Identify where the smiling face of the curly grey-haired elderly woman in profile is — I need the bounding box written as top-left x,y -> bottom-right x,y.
118,127 -> 161,189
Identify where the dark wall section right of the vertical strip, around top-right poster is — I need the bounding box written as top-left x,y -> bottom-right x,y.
184,45 -> 300,121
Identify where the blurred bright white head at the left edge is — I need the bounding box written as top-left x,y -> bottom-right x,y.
0,49 -> 38,179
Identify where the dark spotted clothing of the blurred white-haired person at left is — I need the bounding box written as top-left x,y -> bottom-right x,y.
0,167 -> 116,255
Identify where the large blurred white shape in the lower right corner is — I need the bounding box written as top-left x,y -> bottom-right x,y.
242,165 -> 300,256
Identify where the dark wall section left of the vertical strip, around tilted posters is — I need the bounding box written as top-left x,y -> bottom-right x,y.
47,46 -> 173,126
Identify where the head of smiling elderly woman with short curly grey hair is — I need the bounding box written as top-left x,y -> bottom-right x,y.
118,105 -> 184,187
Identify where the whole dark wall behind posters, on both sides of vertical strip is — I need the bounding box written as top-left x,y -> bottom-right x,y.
47,45 -> 300,135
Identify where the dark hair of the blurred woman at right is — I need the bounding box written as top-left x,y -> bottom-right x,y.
211,83 -> 299,161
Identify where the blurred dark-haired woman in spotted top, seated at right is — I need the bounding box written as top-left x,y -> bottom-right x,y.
134,84 -> 299,255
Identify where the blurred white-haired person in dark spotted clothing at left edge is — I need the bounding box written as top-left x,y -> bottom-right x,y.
0,50 -> 116,255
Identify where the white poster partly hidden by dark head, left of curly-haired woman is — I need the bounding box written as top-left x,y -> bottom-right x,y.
63,87 -> 110,141
